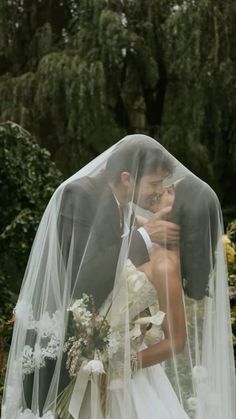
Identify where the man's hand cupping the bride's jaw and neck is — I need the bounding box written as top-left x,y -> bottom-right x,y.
143,207 -> 180,246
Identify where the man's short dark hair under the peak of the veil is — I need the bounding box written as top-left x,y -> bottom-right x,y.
106,137 -> 174,183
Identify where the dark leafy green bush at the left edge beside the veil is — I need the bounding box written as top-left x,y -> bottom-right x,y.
0,122 -> 62,293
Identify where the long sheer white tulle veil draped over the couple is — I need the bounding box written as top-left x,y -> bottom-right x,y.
2,134 -> 235,419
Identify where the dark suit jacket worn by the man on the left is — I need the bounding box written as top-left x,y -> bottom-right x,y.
59,174 -> 149,306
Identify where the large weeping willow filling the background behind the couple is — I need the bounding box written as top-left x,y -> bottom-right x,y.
0,0 -> 236,213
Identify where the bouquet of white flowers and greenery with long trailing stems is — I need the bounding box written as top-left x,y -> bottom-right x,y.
56,294 -> 119,419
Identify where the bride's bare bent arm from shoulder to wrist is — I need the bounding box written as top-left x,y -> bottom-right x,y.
137,249 -> 186,368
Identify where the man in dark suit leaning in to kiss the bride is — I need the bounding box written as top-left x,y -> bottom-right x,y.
58,136 -> 180,307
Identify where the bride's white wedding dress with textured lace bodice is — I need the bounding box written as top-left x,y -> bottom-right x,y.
96,260 -> 189,419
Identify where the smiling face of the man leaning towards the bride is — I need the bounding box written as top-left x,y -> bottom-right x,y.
134,169 -> 168,209
